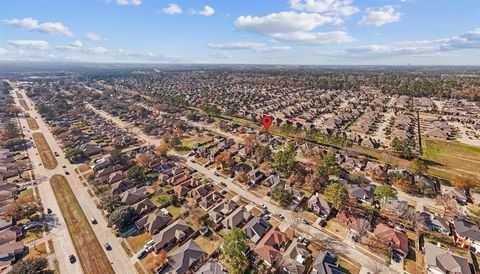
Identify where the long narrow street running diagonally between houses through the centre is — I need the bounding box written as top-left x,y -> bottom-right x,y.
89,105 -> 396,273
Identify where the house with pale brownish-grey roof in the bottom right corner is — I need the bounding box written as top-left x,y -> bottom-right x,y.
425,242 -> 472,274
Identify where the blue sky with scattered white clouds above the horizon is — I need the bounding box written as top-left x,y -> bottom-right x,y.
0,0 -> 480,65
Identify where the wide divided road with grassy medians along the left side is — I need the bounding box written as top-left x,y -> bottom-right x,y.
16,91 -> 136,273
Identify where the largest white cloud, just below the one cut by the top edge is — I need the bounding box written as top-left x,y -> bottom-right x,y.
235,11 -> 354,44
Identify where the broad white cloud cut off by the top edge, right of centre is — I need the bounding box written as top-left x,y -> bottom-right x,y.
290,0 -> 359,16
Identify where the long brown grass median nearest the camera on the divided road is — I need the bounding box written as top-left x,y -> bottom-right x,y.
50,175 -> 115,274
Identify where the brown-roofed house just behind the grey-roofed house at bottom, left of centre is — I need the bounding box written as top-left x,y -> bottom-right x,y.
152,219 -> 191,253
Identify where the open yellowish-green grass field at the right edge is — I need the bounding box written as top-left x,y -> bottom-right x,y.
423,139 -> 480,179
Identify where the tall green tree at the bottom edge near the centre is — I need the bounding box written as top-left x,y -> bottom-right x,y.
222,227 -> 249,274
